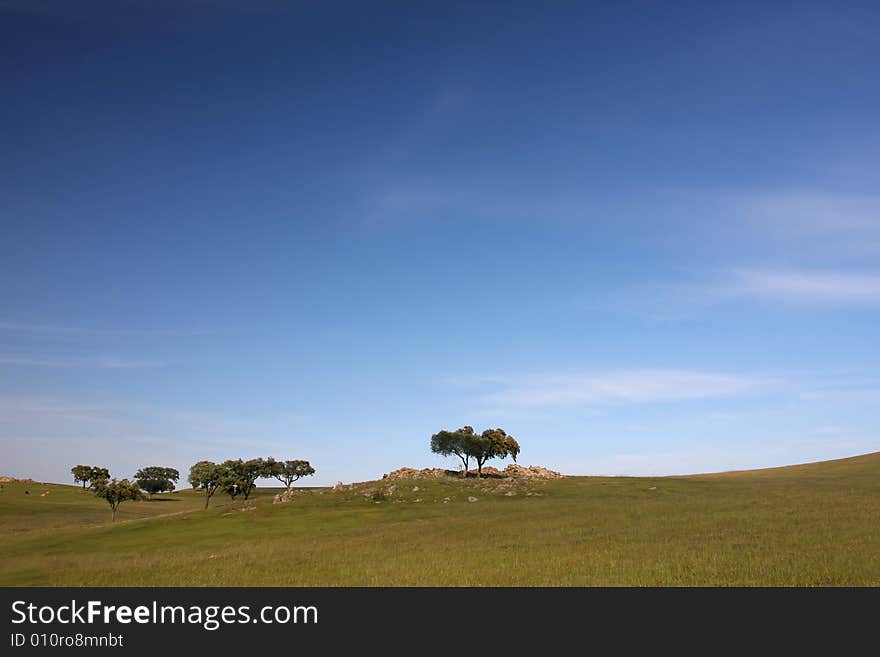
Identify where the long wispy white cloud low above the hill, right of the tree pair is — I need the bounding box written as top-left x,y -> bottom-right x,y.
458,369 -> 770,407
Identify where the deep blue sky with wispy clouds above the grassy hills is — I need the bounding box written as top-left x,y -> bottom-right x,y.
0,0 -> 880,484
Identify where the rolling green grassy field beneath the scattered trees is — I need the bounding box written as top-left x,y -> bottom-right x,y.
0,453 -> 880,586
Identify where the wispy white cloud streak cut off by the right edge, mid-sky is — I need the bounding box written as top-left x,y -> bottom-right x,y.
730,269 -> 880,303
